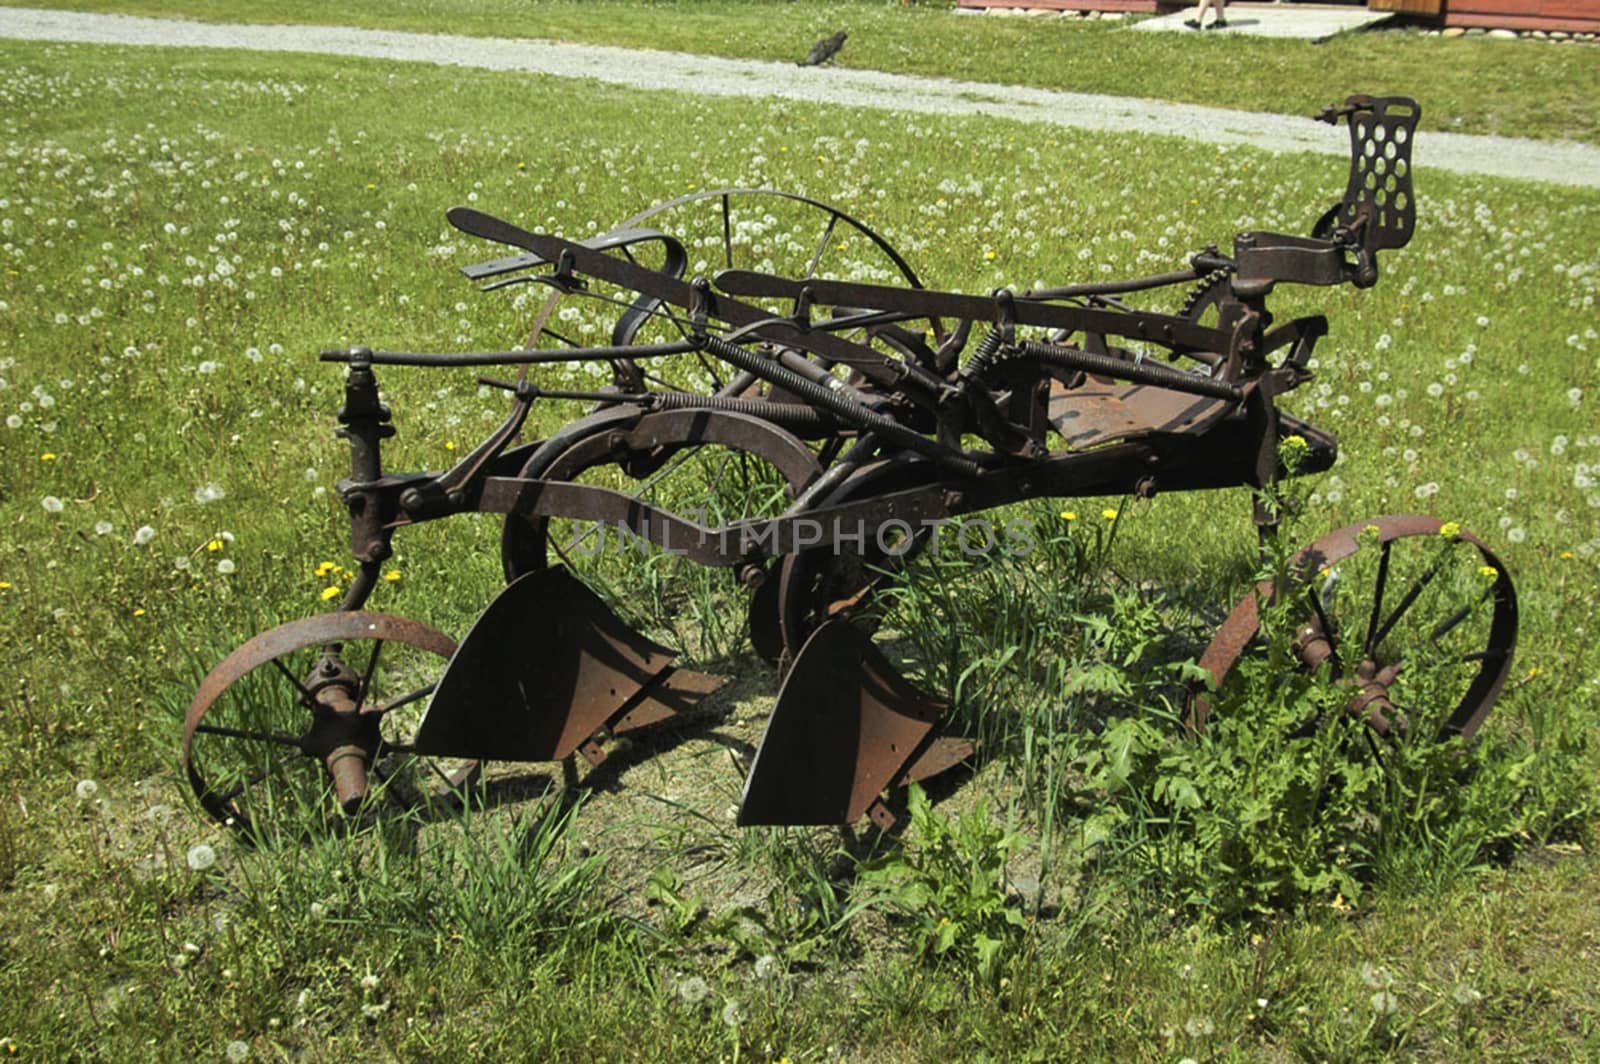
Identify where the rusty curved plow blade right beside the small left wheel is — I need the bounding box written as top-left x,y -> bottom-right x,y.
414,566 -> 722,765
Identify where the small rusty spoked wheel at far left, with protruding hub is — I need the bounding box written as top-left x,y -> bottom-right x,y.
182,611 -> 475,842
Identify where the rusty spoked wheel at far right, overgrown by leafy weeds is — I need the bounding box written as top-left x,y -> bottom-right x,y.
1194,515 -> 1517,739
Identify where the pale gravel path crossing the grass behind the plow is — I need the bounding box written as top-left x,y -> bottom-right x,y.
9,8 -> 1600,187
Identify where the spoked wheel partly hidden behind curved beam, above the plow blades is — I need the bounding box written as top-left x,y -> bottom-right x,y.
501,410 -> 821,661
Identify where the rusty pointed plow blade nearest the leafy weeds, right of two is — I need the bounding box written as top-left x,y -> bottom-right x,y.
739,621 -> 971,829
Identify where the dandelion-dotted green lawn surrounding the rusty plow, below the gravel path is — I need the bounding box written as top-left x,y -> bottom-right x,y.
0,27 -> 1600,1061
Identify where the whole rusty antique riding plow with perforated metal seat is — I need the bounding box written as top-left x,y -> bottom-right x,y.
182,96 -> 1517,832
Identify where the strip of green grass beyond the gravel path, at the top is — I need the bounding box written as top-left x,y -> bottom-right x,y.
9,0 -> 1600,142
